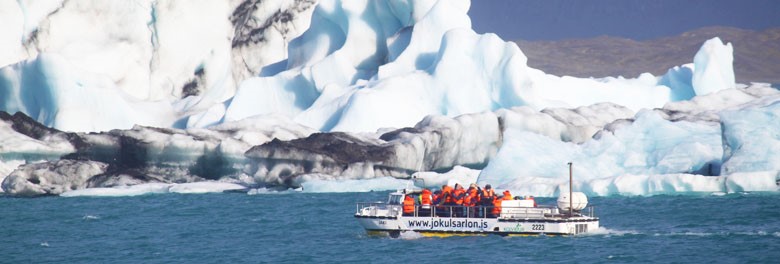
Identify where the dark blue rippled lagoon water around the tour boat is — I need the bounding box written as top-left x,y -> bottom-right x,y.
0,192 -> 780,263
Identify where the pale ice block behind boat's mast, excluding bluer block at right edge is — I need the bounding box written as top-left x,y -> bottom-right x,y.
479,110 -> 722,186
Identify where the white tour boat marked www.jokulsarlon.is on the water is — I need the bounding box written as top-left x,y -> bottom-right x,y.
355,163 -> 599,237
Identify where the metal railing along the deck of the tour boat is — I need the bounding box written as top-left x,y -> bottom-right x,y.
355,202 -> 595,219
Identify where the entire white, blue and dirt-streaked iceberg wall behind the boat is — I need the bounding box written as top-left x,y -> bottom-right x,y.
0,0 -> 780,196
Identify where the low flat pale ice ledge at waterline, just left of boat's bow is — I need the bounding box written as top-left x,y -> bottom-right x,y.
301,177 -> 414,193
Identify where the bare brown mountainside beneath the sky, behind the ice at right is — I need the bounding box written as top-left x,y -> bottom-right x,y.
516,27 -> 780,84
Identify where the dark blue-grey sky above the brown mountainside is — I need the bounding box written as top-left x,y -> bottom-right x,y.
469,0 -> 780,40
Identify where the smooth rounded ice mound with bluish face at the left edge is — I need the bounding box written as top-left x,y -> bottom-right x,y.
0,53 -> 175,132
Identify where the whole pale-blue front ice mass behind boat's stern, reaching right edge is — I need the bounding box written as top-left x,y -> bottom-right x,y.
479,85 -> 780,196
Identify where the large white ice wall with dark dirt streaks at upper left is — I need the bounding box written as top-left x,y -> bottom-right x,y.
0,0 -> 314,132
